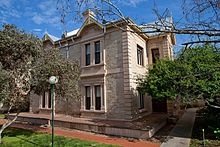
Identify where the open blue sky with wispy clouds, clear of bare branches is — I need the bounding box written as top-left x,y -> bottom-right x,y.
0,0 -> 187,50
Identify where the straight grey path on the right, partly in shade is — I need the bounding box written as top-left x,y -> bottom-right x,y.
161,108 -> 197,147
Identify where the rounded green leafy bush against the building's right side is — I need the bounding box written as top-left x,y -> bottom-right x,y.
138,59 -> 193,100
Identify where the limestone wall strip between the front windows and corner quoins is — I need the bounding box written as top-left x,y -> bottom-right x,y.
104,29 -> 131,119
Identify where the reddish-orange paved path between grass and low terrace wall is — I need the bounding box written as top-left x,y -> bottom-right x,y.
0,119 -> 160,147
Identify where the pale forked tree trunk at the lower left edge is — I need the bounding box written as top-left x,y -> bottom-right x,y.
0,106 -> 19,144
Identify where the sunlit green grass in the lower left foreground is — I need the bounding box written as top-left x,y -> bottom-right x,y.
1,128 -> 119,147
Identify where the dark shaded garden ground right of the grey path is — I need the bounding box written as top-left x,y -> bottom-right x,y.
190,109 -> 220,147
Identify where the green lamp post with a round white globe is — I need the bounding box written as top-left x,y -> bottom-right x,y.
49,76 -> 58,147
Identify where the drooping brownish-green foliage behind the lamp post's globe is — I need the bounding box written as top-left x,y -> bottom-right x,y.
32,48 -> 80,99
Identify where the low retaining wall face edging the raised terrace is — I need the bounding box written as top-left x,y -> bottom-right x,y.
9,116 -> 166,139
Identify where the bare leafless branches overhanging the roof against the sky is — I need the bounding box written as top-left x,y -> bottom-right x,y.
57,0 -> 220,45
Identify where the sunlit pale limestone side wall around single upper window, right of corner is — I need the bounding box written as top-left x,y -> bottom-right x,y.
124,29 -> 152,118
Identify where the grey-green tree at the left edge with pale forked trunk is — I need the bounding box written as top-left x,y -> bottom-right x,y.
0,25 -> 41,143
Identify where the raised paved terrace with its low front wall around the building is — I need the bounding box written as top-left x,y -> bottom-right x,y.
9,113 -> 167,139
